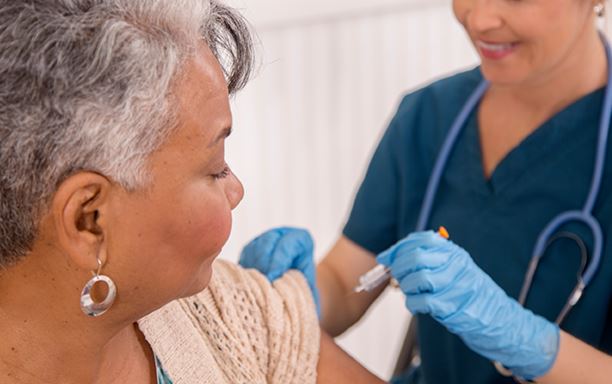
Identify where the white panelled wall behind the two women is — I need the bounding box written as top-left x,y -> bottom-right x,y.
222,0 -> 608,378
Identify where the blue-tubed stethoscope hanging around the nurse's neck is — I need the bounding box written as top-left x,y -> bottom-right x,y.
416,35 -> 612,376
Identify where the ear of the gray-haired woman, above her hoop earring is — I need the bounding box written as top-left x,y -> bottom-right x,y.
51,172 -> 113,271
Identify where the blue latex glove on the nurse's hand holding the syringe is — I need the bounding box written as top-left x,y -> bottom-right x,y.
376,231 -> 559,379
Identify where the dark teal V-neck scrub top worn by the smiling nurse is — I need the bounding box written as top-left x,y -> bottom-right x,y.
343,68 -> 612,384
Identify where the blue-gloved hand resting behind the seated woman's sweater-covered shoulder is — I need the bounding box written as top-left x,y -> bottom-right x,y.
239,227 -> 321,315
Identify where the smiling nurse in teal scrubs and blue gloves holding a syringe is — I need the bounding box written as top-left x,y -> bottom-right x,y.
242,0 -> 612,384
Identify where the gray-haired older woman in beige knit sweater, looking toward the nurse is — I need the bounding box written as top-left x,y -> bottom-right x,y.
0,0 -> 378,384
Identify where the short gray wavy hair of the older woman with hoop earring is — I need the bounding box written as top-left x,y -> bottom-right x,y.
0,0 -> 253,268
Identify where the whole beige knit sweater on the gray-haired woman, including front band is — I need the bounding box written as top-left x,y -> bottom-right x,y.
138,261 -> 320,384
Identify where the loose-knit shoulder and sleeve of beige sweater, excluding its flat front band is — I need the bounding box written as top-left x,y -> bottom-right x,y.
181,260 -> 320,384
